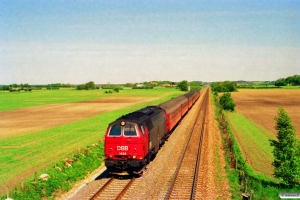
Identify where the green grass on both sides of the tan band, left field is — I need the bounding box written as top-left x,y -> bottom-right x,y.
0,88 -> 182,188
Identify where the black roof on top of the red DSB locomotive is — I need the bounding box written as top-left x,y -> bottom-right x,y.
116,106 -> 163,124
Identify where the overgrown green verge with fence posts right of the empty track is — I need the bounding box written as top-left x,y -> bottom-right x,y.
214,90 -> 300,199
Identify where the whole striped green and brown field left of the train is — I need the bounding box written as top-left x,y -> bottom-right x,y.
0,88 -> 182,189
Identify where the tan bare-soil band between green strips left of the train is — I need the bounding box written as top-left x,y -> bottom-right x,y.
0,97 -> 155,139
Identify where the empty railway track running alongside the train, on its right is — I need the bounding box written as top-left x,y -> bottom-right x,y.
165,91 -> 209,199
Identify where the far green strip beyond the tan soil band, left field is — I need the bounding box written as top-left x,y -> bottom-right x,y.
0,88 -> 180,112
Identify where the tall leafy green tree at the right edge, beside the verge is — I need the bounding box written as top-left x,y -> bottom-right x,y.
270,107 -> 300,184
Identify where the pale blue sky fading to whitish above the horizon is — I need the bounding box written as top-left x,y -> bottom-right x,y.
0,0 -> 300,84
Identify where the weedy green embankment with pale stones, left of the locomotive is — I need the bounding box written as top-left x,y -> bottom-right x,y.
1,142 -> 104,200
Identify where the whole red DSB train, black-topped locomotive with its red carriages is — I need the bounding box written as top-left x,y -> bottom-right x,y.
105,90 -> 200,174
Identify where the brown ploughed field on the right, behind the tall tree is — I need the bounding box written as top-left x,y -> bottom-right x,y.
231,89 -> 300,138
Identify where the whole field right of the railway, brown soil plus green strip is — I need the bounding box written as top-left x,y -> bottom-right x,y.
227,89 -> 300,177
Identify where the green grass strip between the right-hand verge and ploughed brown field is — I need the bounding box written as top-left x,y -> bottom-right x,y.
226,112 -> 276,177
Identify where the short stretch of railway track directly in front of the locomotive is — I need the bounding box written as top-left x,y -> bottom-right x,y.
89,178 -> 135,200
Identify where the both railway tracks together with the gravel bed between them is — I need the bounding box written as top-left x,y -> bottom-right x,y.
69,89 -> 209,200
